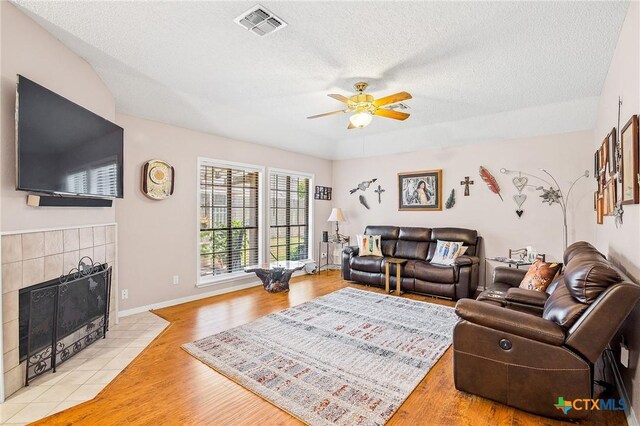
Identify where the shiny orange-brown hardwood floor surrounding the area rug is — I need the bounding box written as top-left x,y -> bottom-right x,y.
36,272 -> 626,426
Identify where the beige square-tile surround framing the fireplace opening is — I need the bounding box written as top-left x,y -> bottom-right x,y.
2,224 -> 118,398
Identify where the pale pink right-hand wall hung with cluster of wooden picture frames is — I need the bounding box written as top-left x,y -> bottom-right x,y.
591,2 -> 640,420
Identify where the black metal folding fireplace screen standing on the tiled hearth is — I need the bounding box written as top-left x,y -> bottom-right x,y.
19,257 -> 111,384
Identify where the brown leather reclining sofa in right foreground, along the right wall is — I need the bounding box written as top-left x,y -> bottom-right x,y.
453,242 -> 640,420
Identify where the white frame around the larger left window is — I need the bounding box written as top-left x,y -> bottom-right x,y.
196,157 -> 265,287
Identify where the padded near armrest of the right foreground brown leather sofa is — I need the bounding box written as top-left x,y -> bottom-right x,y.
456,299 -> 565,346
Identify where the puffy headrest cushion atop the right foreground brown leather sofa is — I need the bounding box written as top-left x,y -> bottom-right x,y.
564,252 -> 623,304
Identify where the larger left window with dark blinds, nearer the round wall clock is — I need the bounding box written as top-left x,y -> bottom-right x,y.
199,160 -> 261,283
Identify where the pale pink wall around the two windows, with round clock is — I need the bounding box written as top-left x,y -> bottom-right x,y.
116,114 -> 331,310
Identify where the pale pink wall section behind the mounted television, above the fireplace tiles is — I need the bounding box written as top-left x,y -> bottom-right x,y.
0,1 -> 115,232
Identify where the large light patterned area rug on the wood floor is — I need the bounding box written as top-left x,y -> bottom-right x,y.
182,288 -> 457,425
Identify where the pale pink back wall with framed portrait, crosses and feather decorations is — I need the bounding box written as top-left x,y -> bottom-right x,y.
333,131 -> 594,270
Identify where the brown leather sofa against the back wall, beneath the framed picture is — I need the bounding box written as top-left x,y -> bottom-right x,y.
342,226 -> 480,300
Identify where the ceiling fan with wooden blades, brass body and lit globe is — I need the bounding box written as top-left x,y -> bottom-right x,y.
307,82 -> 411,129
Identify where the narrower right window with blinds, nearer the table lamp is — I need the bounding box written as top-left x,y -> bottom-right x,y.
269,170 -> 311,261
